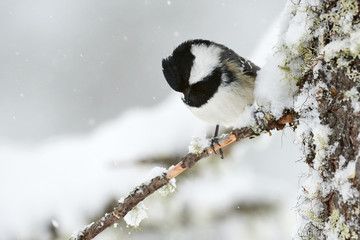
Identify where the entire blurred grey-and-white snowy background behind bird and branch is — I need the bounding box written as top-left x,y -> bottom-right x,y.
0,0 -> 303,240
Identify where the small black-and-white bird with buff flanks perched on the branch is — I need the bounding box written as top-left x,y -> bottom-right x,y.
162,39 -> 260,158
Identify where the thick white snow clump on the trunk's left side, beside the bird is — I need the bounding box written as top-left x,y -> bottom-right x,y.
254,1 -> 309,117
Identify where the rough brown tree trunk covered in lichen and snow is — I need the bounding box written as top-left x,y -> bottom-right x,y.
292,0 -> 360,239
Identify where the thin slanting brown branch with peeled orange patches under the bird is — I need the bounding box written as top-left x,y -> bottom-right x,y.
70,112 -> 295,240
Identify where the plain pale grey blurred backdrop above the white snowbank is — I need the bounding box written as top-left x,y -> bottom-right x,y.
0,0 -> 285,143
